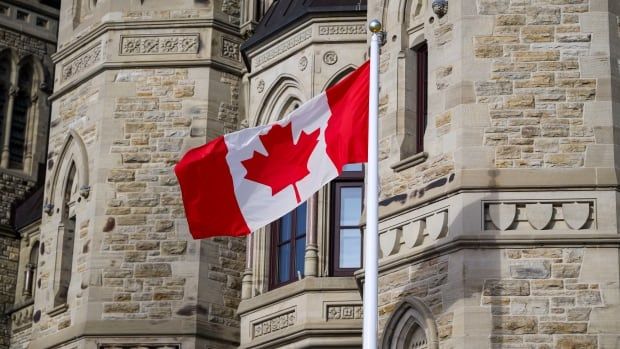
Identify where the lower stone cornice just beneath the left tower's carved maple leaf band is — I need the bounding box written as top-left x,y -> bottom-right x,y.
48,59 -> 241,101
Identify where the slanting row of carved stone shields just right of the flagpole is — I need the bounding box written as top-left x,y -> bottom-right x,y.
379,208 -> 448,257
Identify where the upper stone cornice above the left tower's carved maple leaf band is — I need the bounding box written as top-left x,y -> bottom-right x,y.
52,19 -> 239,64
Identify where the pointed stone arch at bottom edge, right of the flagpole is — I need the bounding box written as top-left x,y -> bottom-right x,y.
381,296 -> 439,349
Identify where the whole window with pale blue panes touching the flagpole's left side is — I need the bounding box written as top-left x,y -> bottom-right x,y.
331,164 -> 364,276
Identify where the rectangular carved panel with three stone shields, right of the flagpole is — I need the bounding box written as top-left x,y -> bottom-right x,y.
484,201 -> 595,231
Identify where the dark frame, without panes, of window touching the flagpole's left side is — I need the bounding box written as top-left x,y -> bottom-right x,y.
329,165 -> 366,276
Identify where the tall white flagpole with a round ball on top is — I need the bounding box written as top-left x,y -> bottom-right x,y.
363,19 -> 382,349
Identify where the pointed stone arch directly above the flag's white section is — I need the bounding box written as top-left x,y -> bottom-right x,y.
254,74 -> 305,126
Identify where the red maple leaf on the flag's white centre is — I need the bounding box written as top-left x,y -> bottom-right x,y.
241,122 -> 321,203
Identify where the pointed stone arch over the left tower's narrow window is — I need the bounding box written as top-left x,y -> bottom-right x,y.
48,129 -> 90,212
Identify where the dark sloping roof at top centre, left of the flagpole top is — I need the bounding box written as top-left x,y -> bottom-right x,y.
241,0 -> 367,60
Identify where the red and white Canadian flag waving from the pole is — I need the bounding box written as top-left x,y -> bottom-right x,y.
174,62 -> 369,239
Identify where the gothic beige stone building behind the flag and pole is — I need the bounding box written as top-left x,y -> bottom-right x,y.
0,0 -> 620,349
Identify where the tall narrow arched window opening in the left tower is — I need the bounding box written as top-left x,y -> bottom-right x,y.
54,162 -> 79,306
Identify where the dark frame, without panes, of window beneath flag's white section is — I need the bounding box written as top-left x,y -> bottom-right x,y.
269,202 -> 308,290
